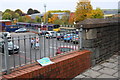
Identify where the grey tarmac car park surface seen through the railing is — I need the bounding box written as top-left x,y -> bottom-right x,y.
2,32 -> 78,68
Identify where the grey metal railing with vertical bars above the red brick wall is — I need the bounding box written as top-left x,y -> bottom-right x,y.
2,28 -> 82,74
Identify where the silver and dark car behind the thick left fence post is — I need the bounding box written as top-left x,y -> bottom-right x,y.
0,39 -> 19,54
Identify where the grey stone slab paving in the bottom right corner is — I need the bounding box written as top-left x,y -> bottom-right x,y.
73,55 -> 120,80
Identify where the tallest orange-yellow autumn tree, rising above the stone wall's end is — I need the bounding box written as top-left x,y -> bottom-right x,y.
75,0 -> 92,22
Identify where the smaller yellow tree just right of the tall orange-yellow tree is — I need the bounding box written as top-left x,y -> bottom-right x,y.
88,8 -> 104,18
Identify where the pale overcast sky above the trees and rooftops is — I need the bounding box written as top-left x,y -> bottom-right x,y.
0,0 -> 119,13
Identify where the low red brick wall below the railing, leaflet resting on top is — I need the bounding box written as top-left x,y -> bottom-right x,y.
3,50 -> 91,80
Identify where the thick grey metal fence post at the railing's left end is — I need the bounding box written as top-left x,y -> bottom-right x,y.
3,34 -> 10,74
